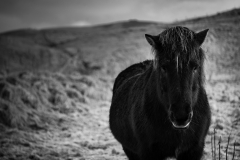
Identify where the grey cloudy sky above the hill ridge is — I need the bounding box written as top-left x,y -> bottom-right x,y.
0,0 -> 240,32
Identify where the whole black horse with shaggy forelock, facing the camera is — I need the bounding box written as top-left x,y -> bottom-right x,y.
110,26 -> 211,160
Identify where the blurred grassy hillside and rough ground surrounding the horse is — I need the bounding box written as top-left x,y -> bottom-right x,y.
0,9 -> 240,160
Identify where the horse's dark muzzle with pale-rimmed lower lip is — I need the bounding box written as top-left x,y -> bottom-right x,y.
170,111 -> 193,129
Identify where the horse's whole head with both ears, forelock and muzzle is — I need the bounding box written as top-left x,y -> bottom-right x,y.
145,26 -> 208,129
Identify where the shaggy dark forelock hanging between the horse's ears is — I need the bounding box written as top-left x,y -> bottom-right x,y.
153,26 -> 201,68
